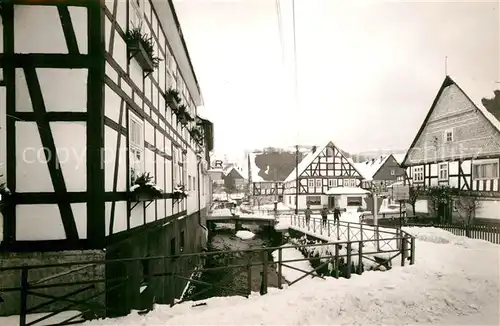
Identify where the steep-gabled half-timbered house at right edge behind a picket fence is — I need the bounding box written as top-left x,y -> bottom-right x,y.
403,76 -> 500,221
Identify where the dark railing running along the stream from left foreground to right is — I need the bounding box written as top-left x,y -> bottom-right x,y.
0,217 -> 415,326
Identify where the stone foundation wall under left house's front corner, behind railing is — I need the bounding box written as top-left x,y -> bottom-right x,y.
0,250 -> 105,316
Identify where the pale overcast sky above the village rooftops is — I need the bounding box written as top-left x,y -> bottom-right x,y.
174,0 -> 500,154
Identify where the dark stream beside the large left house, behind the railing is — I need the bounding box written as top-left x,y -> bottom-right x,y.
184,223 -> 280,301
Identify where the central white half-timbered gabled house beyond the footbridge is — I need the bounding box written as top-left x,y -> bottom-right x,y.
283,142 -> 363,210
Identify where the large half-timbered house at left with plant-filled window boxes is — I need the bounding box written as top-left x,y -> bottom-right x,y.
0,0 -> 213,312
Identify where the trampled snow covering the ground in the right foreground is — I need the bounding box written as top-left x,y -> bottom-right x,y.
84,228 -> 500,325
